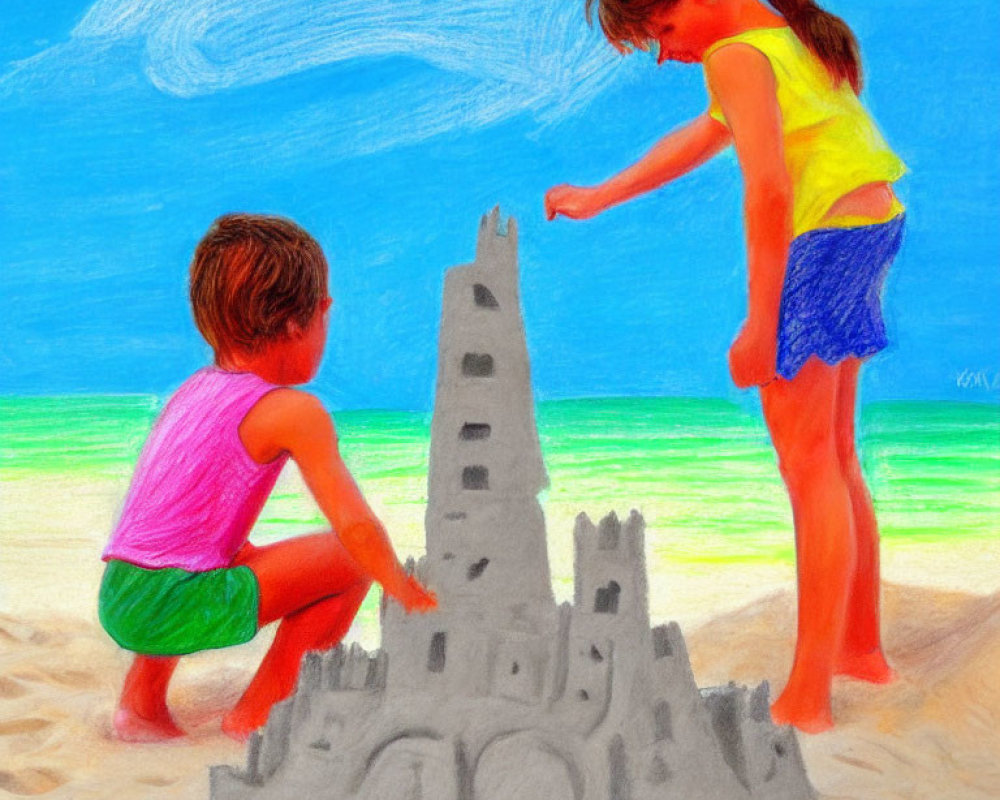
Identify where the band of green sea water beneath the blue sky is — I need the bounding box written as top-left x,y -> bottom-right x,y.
0,396 -> 1000,558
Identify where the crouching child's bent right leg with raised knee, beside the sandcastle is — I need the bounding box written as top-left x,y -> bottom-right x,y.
222,533 -> 371,739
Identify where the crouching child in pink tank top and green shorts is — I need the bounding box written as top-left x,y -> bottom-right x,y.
100,214 -> 436,741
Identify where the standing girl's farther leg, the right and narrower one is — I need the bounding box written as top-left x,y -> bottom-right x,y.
836,358 -> 894,683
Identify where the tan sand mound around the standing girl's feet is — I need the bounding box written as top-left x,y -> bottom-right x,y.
689,584 -> 1000,800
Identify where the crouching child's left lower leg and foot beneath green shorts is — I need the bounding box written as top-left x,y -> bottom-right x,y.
114,655 -> 184,742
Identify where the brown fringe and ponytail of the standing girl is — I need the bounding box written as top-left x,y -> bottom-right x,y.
584,0 -> 862,94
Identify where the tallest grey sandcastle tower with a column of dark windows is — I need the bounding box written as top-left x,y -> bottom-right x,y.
383,209 -> 556,703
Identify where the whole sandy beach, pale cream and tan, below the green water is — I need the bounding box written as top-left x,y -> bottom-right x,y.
0,460 -> 1000,800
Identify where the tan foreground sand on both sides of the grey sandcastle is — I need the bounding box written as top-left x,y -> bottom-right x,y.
0,584 -> 1000,800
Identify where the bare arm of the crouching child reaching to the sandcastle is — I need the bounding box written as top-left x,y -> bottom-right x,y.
240,389 -> 436,611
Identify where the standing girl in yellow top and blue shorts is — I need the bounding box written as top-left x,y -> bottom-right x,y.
545,0 -> 905,732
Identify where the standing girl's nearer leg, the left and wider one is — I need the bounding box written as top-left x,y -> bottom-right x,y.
761,358 -> 855,732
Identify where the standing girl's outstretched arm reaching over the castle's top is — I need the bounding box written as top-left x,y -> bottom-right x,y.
545,114 -> 731,219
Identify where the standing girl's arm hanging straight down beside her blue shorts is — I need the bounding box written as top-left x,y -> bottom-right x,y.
705,43 -> 792,388
